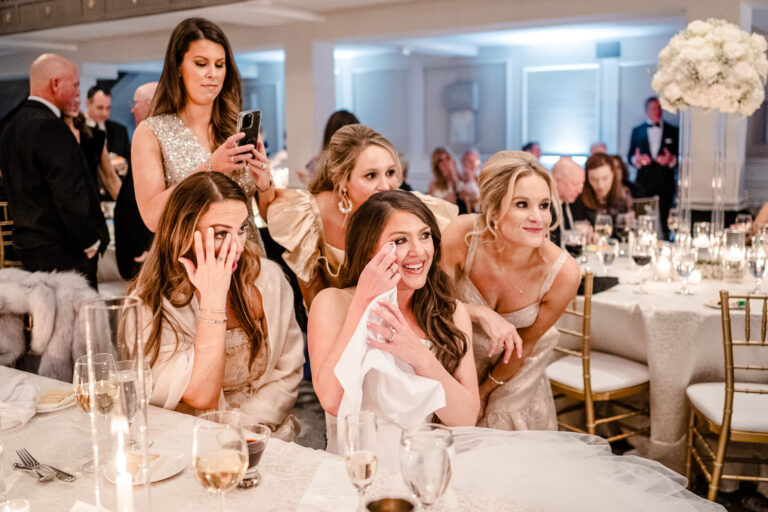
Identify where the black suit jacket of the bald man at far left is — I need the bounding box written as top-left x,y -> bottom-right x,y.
0,100 -> 109,254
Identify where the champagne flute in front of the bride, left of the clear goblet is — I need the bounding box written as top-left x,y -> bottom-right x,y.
344,412 -> 378,512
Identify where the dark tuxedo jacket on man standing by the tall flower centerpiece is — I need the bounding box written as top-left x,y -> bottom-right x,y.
627,123 -> 680,201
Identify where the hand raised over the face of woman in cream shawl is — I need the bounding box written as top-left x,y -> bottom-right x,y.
179,227 -> 238,309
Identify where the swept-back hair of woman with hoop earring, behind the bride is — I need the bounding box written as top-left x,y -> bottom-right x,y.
308,124 -> 403,197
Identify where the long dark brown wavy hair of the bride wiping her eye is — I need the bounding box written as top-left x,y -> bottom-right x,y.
339,190 -> 468,374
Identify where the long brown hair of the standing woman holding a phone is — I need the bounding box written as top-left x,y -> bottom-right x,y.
150,18 -> 242,148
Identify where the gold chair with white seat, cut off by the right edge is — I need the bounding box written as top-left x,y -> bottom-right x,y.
685,290 -> 768,501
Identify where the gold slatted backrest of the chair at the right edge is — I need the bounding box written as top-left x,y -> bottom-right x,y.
720,290 -> 768,430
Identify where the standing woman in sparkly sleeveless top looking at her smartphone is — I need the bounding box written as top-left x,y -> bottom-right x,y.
131,18 -> 275,233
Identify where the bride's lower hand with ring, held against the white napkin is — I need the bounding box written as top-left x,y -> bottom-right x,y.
368,301 -> 434,373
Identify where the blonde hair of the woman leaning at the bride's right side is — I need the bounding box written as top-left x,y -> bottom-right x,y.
469,151 -> 563,239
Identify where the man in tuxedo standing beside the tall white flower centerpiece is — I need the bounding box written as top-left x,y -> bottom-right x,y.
627,96 -> 679,240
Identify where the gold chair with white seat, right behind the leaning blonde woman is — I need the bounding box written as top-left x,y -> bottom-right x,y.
547,272 -> 650,443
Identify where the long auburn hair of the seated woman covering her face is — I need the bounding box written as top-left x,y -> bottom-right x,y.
131,172 -> 267,364
